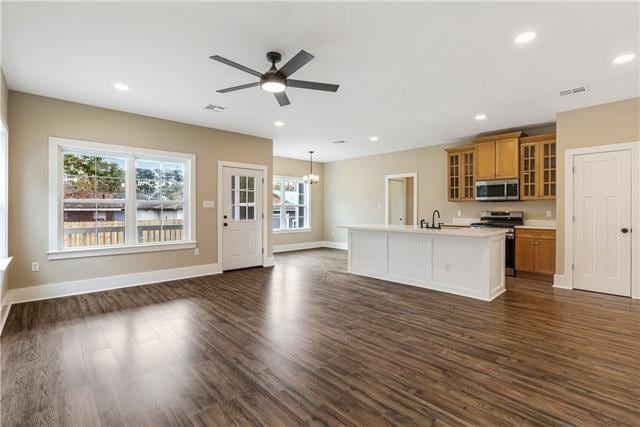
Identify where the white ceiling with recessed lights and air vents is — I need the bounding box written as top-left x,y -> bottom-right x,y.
2,1 -> 640,161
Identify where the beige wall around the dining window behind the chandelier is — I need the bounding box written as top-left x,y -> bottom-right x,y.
273,157 -> 325,246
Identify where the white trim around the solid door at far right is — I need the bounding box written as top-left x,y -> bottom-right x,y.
554,141 -> 640,298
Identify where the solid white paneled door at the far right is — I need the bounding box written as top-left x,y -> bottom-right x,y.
573,150 -> 631,296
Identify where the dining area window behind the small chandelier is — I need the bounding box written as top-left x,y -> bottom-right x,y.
272,176 -> 311,232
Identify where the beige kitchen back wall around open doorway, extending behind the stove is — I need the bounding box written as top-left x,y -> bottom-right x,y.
324,143 -> 555,242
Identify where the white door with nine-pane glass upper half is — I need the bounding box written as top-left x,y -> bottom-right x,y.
222,166 -> 264,270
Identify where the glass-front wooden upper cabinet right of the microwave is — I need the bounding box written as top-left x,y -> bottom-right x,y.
520,133 -> 557,200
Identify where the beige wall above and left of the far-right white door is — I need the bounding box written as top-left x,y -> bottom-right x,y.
556,98 -> 640,274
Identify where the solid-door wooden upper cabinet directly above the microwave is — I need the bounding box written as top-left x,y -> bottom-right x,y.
473,132 -> 524,180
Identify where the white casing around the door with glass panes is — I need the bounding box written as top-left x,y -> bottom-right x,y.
216,160 -> 274,269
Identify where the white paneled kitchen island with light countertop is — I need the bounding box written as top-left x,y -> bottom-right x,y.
341,225 -> 505,301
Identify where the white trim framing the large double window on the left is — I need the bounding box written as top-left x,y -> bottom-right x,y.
48,137 -> 197,260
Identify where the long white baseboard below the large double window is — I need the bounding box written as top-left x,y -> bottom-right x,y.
4,264 -> 222,304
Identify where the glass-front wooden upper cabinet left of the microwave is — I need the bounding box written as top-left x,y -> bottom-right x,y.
447,146 -> 476,202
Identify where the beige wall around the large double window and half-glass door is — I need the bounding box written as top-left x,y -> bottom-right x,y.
9,91 -> 273,288
